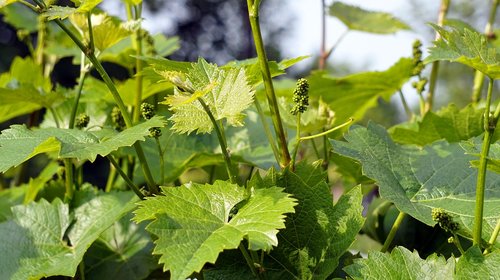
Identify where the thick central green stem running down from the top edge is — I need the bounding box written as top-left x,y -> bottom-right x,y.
247,0 -> 291,167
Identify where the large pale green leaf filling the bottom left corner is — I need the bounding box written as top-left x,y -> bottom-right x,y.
0,191 -> 137,279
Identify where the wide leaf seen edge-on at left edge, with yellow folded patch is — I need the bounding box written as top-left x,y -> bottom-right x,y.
0,116 -> 165,172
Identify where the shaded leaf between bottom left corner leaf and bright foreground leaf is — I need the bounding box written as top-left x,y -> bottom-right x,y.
84,213 -> 158,280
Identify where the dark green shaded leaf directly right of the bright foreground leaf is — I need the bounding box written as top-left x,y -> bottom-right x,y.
261,162 -> 364,279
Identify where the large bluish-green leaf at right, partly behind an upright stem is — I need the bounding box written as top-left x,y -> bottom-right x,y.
331,123 -> 500,242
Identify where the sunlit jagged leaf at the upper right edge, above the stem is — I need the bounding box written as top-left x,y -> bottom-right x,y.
424,25 -> 500,79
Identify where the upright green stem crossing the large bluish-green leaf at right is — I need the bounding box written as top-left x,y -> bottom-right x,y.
472,78 -> 496,245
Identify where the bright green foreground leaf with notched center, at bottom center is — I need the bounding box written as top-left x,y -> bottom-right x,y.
134,181 -> 295,280
